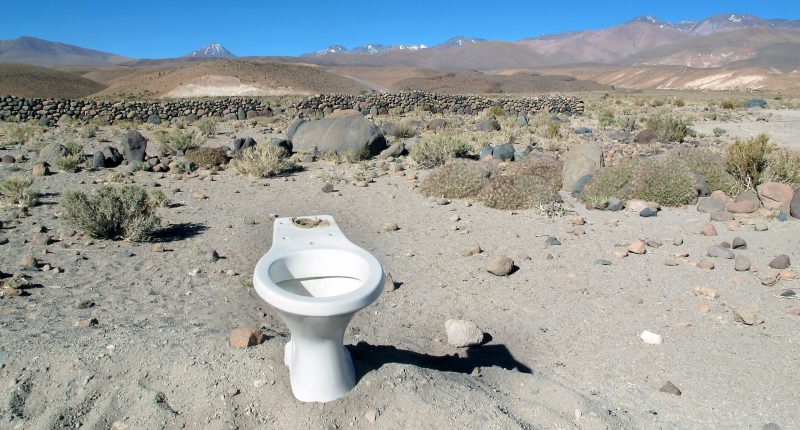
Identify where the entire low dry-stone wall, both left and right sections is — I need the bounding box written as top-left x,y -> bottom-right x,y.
0,91 -> 584,125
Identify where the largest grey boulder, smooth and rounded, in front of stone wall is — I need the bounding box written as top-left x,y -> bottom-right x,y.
288,115 -> 386,156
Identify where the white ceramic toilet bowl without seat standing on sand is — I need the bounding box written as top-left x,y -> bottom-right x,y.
253,215 -> 384,402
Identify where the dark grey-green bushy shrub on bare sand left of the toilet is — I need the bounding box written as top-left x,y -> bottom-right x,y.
61,185 -> 165,242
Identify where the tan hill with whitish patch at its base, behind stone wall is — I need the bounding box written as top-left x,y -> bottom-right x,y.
83,60 -> 367,98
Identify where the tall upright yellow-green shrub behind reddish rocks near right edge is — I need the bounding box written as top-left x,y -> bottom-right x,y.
725,133 -> 773,189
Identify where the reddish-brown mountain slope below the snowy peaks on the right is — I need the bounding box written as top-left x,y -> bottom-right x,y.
519,22 -> 691,64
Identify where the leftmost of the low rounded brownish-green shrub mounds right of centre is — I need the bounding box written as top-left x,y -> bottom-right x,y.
419,159 -> 493,199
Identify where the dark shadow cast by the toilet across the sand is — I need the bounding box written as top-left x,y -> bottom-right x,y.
347,342 -> 532,380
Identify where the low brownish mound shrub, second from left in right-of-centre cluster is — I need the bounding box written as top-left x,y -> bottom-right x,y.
478,175 -> 560,210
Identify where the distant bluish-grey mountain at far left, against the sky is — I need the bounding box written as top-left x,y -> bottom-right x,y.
0,36 -> 130,67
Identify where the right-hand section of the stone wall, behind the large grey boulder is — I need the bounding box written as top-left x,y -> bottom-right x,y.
295,91 -> 584,117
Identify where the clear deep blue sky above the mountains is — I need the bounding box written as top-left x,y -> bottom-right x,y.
0,0 -> 800,58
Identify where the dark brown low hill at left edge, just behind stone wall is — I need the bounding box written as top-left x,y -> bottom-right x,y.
0,63 -> 105,98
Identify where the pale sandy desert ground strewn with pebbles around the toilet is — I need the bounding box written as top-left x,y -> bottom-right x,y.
0,92 -> 800,430
